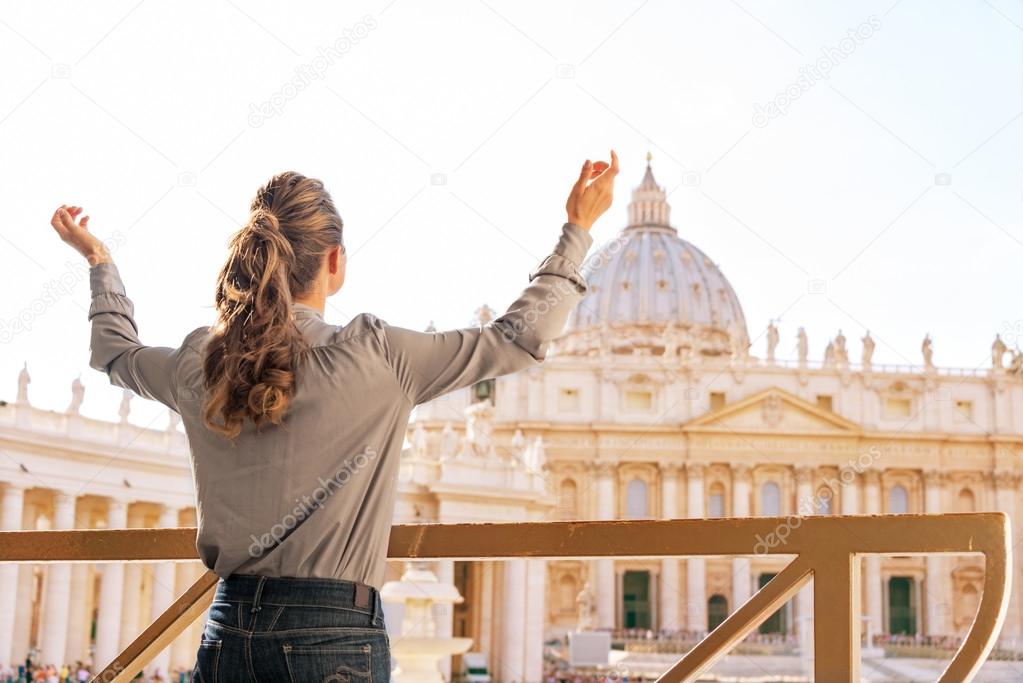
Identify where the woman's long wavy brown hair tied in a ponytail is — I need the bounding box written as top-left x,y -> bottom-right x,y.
203,172 -> 344,439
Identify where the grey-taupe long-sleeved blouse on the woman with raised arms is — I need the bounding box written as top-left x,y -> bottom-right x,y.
89,223 -> 592,587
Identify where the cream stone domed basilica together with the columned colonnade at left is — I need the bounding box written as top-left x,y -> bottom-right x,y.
0,162 -> 1023,683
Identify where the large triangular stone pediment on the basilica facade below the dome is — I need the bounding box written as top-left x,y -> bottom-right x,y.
683,388 -> 861,434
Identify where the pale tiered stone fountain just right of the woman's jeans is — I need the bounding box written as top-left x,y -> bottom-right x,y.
381,562 -> 473,683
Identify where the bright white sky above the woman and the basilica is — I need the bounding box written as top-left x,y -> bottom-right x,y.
0,0 -> 1023,426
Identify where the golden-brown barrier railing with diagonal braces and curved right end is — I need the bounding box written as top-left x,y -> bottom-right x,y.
0,512 -> 1012,683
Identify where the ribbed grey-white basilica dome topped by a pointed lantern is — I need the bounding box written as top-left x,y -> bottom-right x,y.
560,156 -> 749,356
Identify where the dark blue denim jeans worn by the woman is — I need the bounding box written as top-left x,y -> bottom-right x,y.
192,575 -> 391,683
